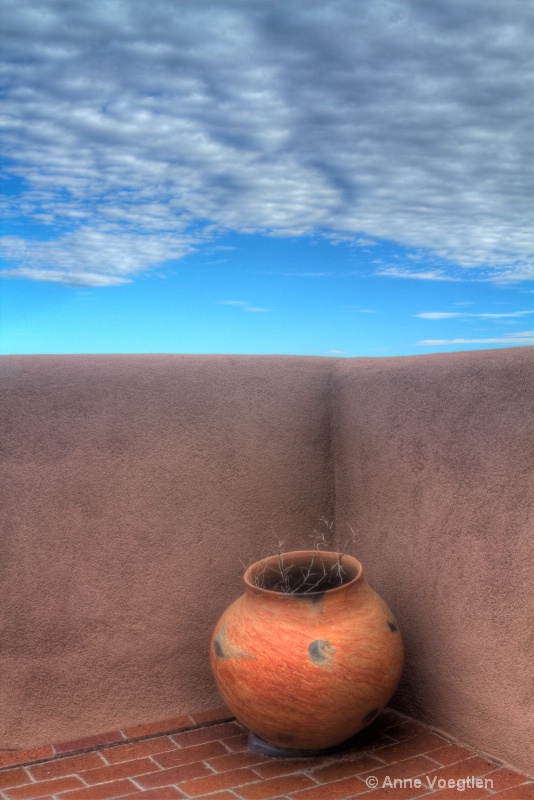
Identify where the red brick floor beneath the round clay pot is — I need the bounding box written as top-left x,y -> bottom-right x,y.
0,709 -> 534,800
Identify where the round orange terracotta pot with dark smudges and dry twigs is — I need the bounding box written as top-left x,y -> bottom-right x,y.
211,551 -> 404,750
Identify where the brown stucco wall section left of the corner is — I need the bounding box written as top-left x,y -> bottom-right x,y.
0,356 -> 333,749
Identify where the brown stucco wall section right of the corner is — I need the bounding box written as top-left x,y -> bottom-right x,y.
333,348 -> 534,774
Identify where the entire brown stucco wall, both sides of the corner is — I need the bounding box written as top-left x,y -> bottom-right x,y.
0,348 -> 534,773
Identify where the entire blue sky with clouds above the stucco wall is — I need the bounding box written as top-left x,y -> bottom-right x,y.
0,0 -> 534,356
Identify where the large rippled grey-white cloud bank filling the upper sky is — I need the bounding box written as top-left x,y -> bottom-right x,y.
0,0 -> 534,285
